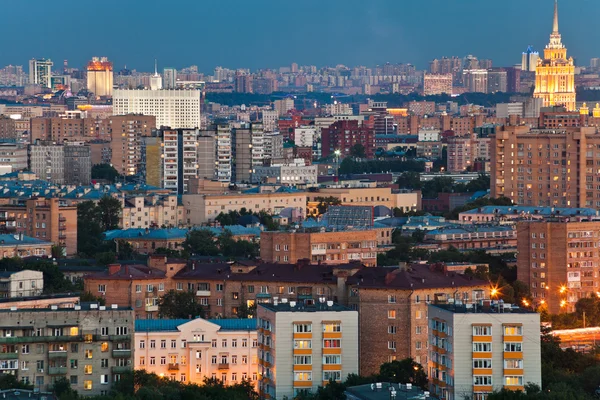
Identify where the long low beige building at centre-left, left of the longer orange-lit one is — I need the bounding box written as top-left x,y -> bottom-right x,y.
182,191 -> 307,225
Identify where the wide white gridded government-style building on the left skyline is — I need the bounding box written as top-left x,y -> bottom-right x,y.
113,89 -> 200,129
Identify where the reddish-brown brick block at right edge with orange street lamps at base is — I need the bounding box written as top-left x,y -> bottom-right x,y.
517,217 -> 600,314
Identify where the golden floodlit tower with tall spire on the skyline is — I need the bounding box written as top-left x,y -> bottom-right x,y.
533,0 -> 576,111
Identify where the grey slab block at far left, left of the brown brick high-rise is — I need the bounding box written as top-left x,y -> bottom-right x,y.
29,144 -> 92,185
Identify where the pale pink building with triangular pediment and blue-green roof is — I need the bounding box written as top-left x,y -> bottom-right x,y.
134,318 -> 258,385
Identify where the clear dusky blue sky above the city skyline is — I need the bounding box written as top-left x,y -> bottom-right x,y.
0,0 -> 600,73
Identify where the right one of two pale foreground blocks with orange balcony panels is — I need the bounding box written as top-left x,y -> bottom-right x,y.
428,300 -> 542,400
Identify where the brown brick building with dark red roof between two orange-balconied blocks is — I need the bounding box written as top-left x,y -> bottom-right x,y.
346,265 -> 490,376
